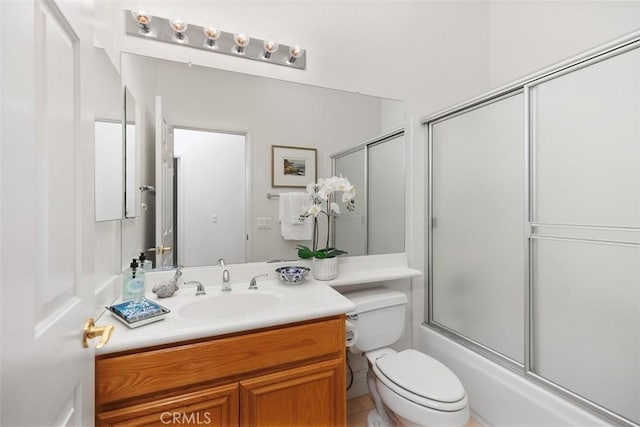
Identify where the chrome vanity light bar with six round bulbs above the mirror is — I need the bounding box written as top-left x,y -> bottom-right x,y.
124,9 -> 307,70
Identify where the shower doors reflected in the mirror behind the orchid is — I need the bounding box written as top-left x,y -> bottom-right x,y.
332,130 -> 405,255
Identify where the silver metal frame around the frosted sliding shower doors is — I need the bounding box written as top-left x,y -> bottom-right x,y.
420,31 -> 640,426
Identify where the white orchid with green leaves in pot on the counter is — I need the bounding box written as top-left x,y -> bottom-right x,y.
296,175 -> 356,259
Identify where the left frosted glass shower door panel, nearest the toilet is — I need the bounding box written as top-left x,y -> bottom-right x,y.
429,92 -> 526,365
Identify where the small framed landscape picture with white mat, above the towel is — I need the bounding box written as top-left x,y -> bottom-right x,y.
271,145 -> 317,188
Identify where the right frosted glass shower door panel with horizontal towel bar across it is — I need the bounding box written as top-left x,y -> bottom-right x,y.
526,44 -> 640,423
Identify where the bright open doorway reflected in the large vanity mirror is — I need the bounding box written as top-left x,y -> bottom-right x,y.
173,128 -> 247,266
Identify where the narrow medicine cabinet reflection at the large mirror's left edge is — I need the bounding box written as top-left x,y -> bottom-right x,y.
124,88 -> 140,218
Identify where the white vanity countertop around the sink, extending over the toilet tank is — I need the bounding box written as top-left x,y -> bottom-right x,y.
96,253 -> 422,355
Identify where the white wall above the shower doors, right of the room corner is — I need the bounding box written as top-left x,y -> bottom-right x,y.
488,0 -> 640,87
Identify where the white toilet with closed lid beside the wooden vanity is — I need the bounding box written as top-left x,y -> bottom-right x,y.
344,288 -> 469,427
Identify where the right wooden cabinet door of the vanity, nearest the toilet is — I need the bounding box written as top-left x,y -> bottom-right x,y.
240,359 -> 346,427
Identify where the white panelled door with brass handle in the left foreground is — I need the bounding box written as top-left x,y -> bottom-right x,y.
0,0 -> 94,426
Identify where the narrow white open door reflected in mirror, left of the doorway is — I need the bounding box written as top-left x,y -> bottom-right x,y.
155,96 -> 174,267
